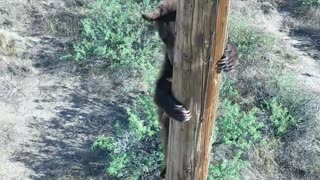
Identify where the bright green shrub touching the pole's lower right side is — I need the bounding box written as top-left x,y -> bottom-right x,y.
209,81 -> 264,180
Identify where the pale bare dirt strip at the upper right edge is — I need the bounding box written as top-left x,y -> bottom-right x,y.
259,3 -> 320,95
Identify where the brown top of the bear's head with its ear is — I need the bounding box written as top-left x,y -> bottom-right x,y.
142,0 -> 177,22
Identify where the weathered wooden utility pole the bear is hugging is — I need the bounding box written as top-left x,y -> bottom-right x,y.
166,0 -> 230,180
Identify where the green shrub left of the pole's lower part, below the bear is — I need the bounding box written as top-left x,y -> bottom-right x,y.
93,96 -> 163,179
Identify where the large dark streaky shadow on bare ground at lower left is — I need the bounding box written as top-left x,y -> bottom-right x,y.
15,94 -> 123,179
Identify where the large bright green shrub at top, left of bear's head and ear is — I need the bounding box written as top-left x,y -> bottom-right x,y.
68,0 -> 160,77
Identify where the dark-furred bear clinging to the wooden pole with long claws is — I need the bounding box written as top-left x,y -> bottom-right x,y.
142,0 -> 238,177
